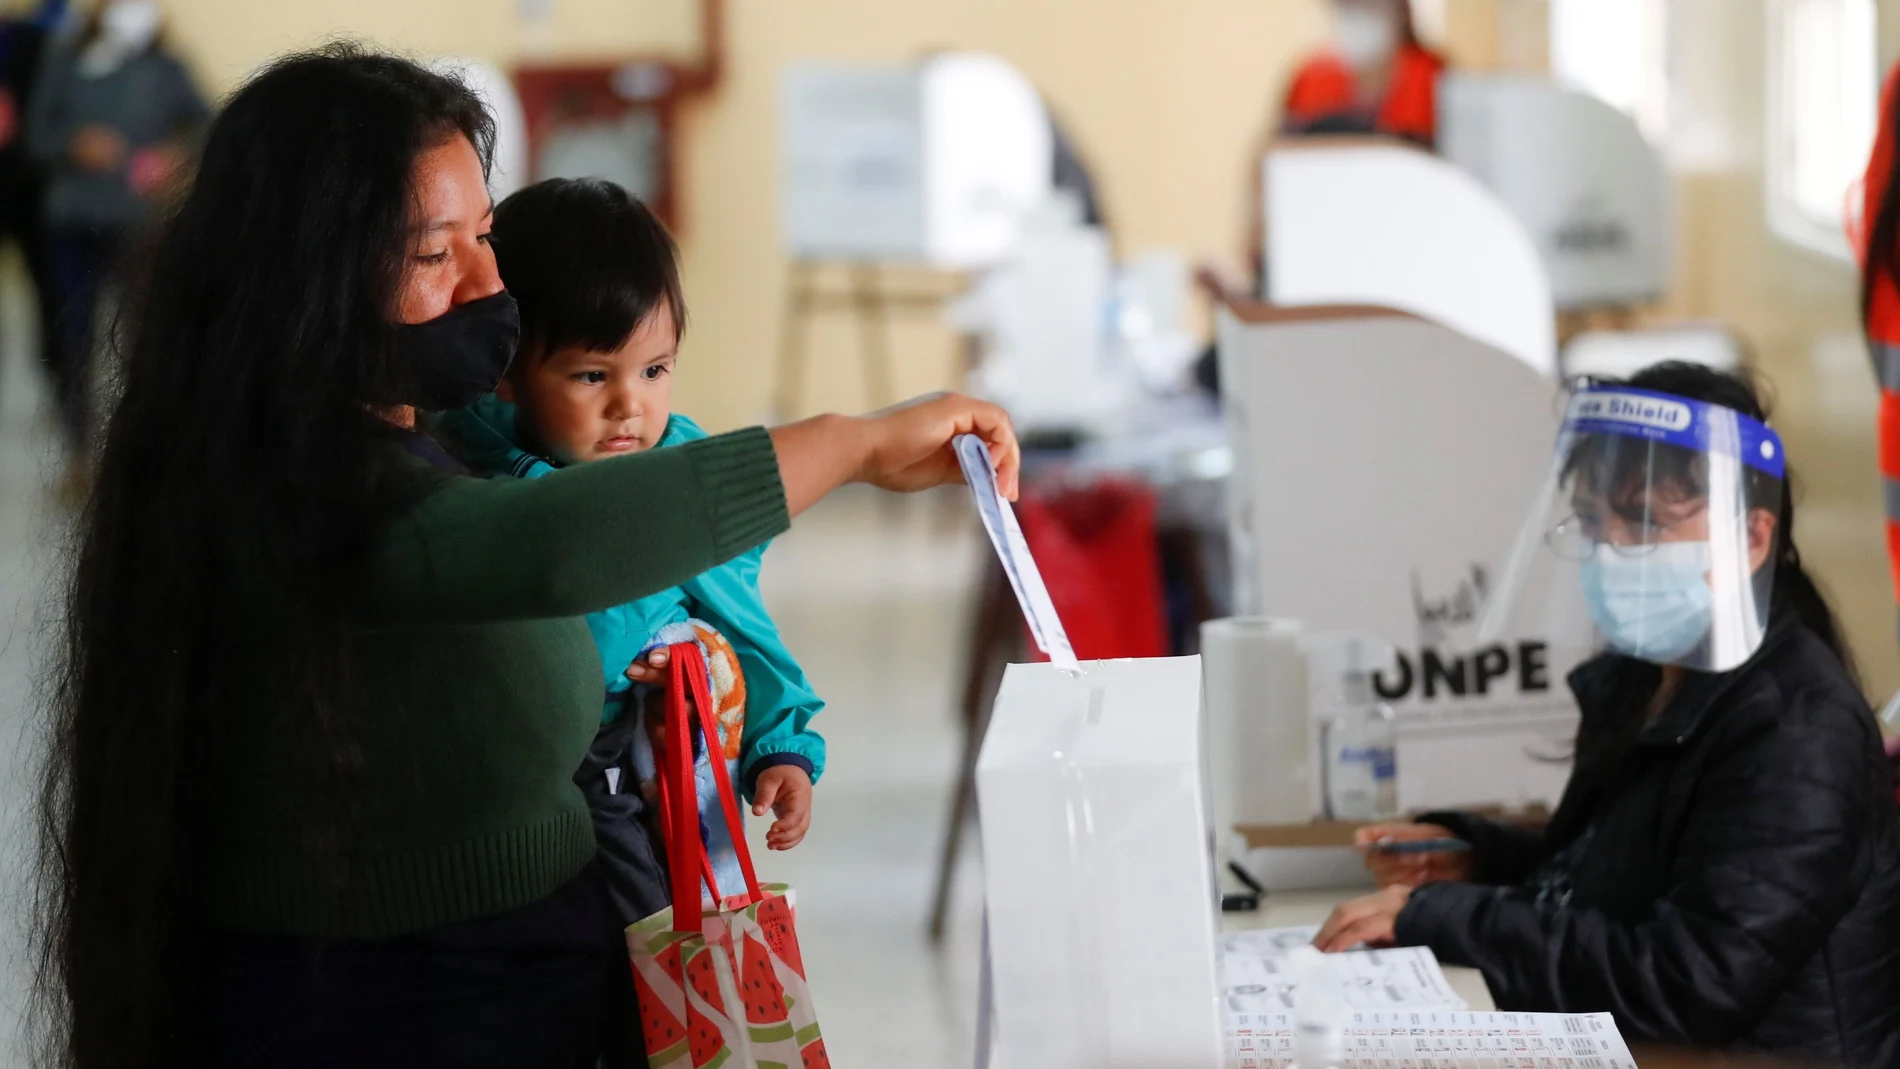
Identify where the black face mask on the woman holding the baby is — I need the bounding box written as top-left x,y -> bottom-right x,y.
397,291 -> 521,412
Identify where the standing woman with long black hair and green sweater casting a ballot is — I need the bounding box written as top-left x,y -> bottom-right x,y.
26,47 -> 1017,1069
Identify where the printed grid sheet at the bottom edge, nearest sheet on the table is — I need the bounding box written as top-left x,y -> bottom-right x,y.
1226,1010 -> 1636,1069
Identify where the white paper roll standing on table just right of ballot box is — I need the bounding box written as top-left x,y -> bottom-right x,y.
1201,617 -> 1315,856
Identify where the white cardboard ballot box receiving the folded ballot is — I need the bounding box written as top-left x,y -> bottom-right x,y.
977,657 -> 1222,1069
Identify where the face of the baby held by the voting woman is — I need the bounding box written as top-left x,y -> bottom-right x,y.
496,302 -> 680,463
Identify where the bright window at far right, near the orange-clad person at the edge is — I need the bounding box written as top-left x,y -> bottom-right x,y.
1767,0 -> 1879,258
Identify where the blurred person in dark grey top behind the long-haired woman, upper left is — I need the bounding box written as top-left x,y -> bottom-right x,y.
25,0 -> 211,471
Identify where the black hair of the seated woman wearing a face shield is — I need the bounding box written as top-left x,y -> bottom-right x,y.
1566,361 -> 1854,773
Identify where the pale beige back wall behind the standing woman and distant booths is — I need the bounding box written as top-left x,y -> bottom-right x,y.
126,0 -> 1324,427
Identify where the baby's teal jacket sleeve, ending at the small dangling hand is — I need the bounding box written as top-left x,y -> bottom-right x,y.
684,547 -> 825,797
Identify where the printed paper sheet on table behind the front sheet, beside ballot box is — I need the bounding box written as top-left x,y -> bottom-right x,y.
1220,927 -> 1467,1020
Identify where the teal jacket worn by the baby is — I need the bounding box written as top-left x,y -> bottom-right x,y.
435,397 -> 825,794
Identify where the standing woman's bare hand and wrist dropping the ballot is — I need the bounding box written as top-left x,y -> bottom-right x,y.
771,393 -> 1022,516
